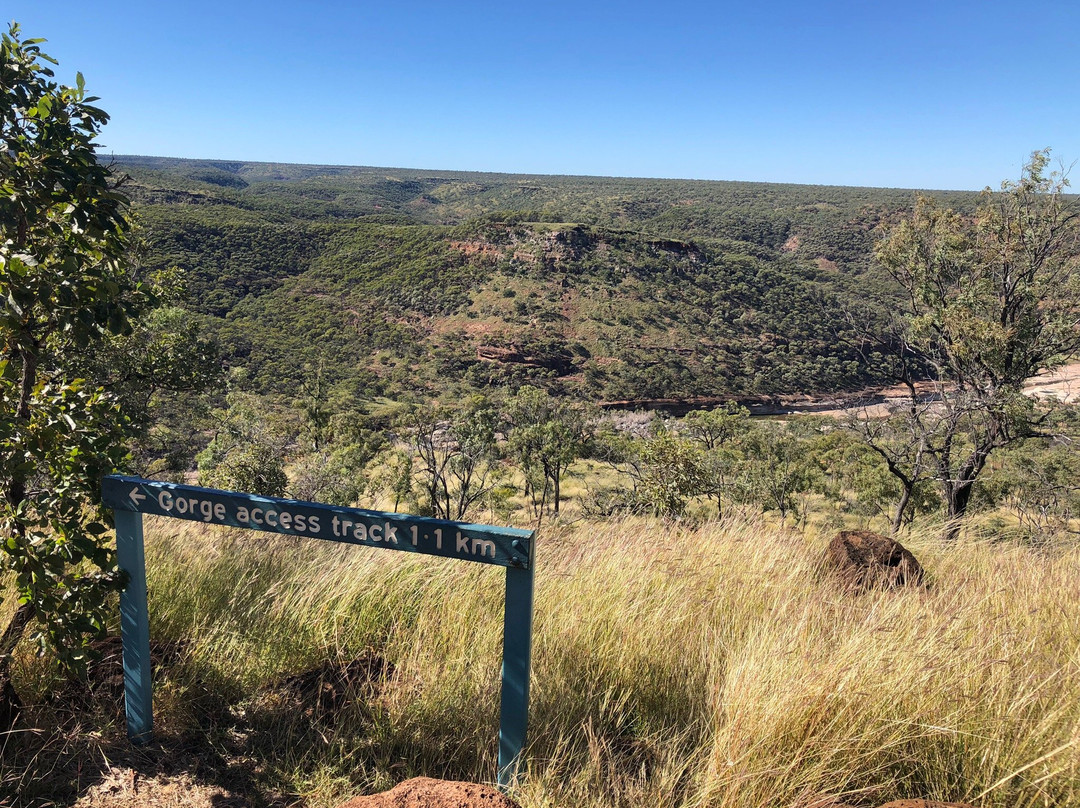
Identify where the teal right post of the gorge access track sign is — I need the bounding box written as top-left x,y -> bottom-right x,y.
499,565 -> 532,791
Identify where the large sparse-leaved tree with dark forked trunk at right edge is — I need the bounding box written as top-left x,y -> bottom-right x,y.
864,150 -> 1080,537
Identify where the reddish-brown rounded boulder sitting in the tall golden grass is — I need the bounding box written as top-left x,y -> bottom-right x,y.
822,530 -> 922,590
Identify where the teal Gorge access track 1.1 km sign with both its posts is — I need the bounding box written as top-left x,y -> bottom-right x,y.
102,474 -> 534,787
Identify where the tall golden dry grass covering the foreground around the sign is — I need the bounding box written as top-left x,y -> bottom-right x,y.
6,520 -> 1080,808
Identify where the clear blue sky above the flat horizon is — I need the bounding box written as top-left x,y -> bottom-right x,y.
4,0 -> 1080,189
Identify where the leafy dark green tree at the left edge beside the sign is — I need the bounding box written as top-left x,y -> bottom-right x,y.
0,25 -> 151,726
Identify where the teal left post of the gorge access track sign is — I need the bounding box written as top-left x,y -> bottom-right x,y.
113,511 -> 153,745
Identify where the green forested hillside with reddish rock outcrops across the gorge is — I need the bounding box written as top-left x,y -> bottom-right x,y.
117,157 -> 976,401
